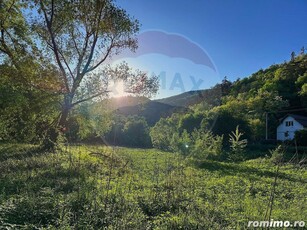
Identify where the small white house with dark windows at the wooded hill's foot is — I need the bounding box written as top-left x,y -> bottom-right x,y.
277,114 -> 307,141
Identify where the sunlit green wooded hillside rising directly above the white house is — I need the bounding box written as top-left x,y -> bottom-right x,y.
229,54 -> 307,109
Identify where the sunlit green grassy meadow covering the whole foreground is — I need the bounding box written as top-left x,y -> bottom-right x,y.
0,144 -> 307,229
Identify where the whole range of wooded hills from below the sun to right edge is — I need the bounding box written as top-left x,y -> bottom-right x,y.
114,55 -> 307,125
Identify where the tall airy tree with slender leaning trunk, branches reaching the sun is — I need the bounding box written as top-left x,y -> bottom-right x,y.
0,0 -> 158,147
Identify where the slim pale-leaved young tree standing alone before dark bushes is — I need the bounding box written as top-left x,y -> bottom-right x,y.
228,126 -> 247,161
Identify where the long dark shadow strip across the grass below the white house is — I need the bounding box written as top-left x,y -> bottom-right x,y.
196,161 -> 307,183
